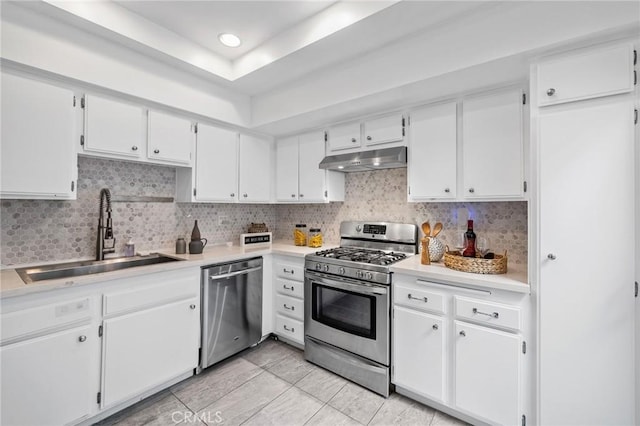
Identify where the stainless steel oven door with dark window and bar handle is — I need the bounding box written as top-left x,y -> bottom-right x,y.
304,271 -> 390,365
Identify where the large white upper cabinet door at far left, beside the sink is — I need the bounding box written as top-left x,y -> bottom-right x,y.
0,73 -> 79,199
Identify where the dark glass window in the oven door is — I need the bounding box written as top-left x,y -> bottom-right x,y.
312,283 -> 376,340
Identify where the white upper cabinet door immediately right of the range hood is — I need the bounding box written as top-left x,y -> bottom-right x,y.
408,102 -> 457,201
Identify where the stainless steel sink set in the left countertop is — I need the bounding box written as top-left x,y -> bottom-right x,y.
16,254 -> 182,284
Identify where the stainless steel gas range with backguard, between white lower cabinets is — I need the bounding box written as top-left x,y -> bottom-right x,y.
304,222 -> 418,397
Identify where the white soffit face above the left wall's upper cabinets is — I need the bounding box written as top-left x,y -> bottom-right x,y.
0,2 -> 251,127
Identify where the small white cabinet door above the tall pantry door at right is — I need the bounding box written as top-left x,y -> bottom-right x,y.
536,44 -> 634,106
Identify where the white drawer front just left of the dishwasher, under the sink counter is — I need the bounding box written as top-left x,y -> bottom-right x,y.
103,269 -> 200,316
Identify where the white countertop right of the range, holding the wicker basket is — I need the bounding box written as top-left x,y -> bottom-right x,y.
391,256 -> 530,293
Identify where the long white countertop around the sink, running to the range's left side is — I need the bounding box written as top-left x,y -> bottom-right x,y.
0,241 -> 329,299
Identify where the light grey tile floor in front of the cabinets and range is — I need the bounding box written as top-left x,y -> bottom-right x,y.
99,339 -> 465,426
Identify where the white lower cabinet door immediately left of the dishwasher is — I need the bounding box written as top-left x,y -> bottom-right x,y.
102,298 -> 200,407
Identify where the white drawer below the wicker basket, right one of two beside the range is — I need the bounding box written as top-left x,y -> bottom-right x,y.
454,296 -> 522,331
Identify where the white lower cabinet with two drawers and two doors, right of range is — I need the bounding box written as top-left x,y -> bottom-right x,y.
391,275 -> 533,425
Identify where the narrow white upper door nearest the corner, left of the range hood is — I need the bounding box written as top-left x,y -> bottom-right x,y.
276,136 -> 298,202
